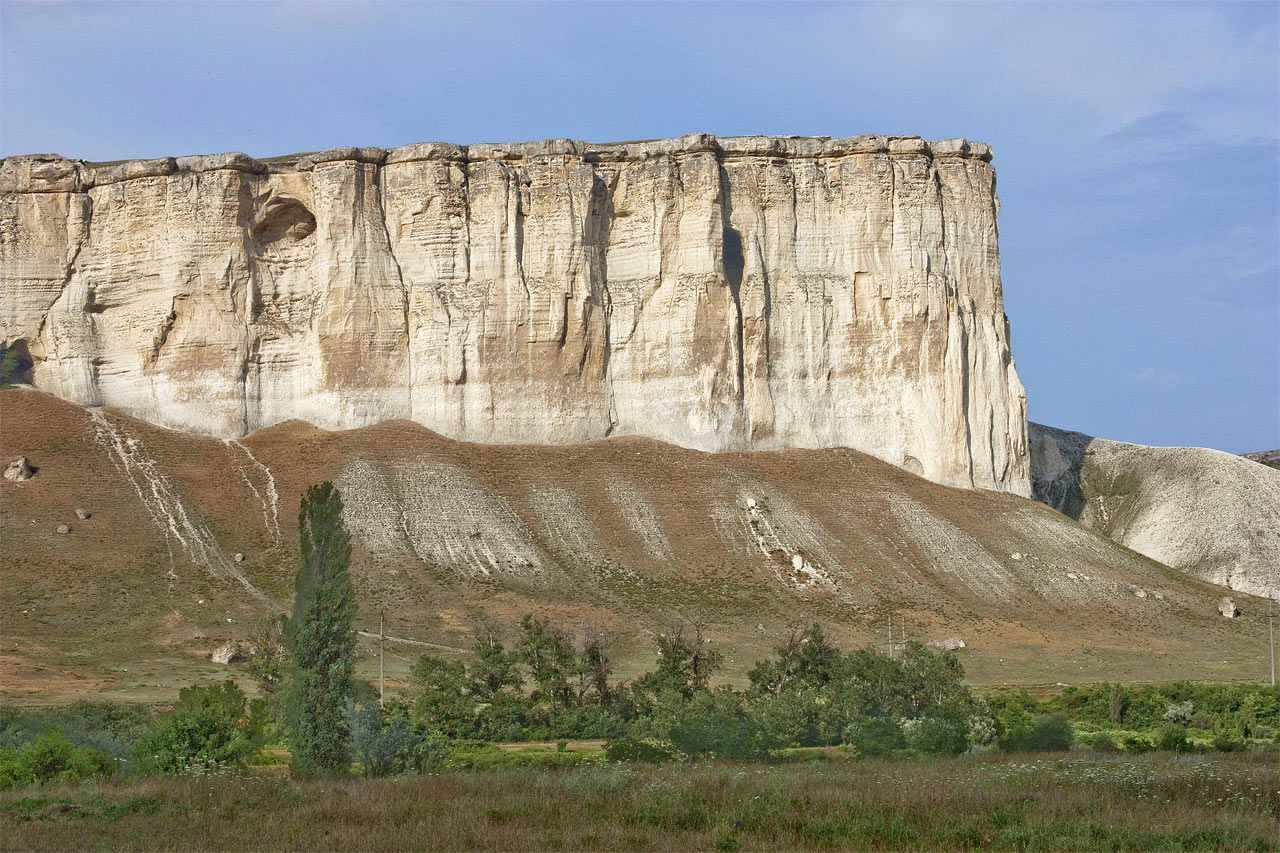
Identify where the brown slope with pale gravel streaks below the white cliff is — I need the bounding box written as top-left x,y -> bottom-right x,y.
0,389 -> 1266,702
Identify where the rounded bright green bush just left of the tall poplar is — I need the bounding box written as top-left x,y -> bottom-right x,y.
137,679 -> 261,774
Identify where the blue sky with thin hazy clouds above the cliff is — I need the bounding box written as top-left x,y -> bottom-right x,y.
0,0 -> 1280,452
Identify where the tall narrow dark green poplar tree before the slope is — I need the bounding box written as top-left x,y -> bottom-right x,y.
285,483 -> 356,774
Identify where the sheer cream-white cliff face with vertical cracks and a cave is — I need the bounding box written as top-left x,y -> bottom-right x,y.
0,134 -> 1030,494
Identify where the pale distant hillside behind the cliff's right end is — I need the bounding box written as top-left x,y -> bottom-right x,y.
1029,424 -> 1280,597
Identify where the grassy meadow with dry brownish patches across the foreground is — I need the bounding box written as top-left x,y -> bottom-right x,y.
0,752 -> 1280,850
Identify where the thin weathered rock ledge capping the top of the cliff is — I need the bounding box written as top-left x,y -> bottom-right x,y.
0,133 -> 992,192
